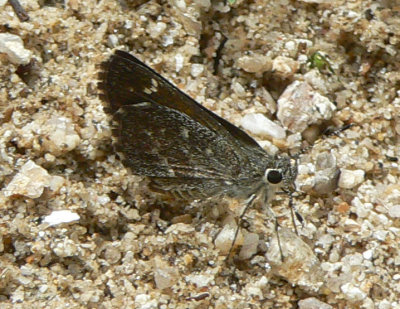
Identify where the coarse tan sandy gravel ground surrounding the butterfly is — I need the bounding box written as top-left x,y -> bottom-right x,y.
0,0 -> 400,309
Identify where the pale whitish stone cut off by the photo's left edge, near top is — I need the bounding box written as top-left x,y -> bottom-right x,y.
0,33 -> 32,64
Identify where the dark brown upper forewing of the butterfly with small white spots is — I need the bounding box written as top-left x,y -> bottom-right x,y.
99,51 -> 265,157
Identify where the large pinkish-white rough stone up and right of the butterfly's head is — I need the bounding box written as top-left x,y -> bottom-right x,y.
277,81 -> 336,133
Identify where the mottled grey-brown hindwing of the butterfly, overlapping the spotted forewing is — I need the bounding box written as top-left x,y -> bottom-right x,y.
114,102 -> 247,181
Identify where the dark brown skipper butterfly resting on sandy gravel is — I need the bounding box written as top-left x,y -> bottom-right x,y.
99,50 -> 297,253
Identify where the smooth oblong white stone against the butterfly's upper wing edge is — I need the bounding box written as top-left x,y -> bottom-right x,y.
241,113 -> 286,139
